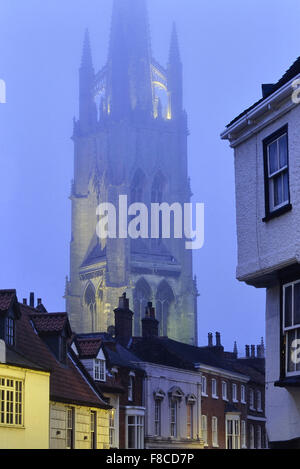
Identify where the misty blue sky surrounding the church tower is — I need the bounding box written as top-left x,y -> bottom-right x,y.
0,0 -> 300,353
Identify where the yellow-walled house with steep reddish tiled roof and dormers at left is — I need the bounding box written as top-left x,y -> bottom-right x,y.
0,290 -> 111,449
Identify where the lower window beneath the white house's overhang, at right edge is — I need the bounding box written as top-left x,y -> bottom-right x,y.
283,280 -> 300,375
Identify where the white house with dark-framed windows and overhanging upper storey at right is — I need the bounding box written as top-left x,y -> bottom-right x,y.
221,59 -> 300,448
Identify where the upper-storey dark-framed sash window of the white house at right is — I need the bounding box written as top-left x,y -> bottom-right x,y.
264,127 -> 290,216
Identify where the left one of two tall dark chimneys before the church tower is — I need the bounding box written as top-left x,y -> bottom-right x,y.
114,293 -> 133,347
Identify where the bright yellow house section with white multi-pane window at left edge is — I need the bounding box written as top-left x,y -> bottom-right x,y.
0,340 -> 50,449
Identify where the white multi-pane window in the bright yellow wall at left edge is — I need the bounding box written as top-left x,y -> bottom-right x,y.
0,378 -> 23,426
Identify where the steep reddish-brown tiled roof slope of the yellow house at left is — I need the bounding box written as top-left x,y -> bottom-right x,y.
9,304 -> 110,409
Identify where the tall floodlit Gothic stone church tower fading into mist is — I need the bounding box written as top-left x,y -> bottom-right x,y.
65,0 -> 197,343
